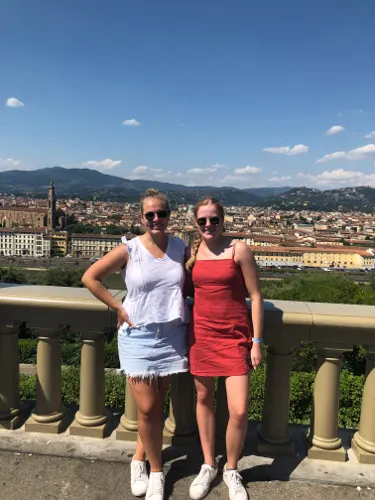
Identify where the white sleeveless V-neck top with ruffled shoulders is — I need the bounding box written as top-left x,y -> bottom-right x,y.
121,236 -> 187,326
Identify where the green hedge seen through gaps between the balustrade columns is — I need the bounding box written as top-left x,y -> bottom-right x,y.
20,367 -> 364,428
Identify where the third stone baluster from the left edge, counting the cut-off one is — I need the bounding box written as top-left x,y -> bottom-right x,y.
70,333 -> 108,438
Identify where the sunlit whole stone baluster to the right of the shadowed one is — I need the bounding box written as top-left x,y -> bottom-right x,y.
307,348 -> 346,462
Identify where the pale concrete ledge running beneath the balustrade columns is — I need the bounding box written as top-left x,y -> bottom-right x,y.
0,426 -> 375,488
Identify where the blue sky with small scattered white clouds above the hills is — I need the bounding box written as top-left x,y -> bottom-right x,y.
0,0 -> 375,189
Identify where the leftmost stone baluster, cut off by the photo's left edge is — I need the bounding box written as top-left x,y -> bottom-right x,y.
0,326 -> 21,430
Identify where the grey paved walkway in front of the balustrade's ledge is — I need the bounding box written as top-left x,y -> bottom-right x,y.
0,452 -> 375,500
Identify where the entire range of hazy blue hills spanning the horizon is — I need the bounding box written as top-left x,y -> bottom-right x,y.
0,167 -> 375,212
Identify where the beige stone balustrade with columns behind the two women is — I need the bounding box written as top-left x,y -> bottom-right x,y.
0,284 -> 375,464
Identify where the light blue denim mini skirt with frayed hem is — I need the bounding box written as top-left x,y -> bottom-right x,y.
118,319 -> 188,379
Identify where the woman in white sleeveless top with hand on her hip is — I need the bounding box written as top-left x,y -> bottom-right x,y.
82,189 -> 188,500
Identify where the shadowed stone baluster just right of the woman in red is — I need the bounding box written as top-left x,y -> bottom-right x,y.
258,346 -> 295,455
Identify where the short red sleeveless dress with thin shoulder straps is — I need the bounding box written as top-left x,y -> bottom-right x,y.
189,258 -> 252,377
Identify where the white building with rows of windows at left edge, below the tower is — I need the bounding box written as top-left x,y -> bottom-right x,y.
0,228 -> 51,258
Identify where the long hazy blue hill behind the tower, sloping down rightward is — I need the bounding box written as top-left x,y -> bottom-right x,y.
0,167 -> 259,205
